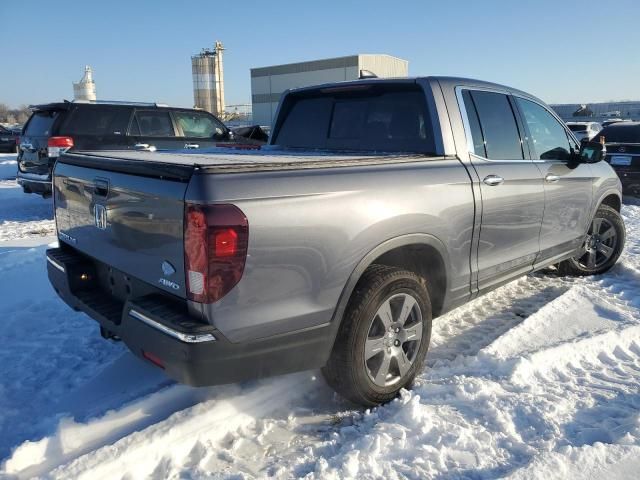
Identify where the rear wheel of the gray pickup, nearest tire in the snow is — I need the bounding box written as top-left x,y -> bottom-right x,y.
322,265 -> 432,407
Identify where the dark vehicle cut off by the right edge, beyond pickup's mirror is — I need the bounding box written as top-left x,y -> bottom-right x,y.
598,122 -> 640,196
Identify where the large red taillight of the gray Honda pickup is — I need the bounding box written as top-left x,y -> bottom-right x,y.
184,203 -> 249,303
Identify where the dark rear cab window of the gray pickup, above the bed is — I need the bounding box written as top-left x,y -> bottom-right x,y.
273,85 -> 435,153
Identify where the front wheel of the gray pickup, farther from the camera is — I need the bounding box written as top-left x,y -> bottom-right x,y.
558,205 -> 626,276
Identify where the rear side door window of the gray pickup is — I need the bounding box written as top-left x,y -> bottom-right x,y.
467,90 -> 524,160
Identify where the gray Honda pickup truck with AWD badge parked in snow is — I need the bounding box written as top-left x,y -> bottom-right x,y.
47,77 -> 625,405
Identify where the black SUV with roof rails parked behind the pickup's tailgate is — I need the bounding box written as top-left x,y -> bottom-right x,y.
18,101 -> 248,197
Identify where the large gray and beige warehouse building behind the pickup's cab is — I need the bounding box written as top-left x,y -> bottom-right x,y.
251,54 -> 409,126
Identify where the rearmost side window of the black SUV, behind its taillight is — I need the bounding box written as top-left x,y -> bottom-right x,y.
60,107 -> 132,135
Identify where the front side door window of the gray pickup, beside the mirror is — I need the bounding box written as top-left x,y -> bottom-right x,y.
516,97 -> 570,160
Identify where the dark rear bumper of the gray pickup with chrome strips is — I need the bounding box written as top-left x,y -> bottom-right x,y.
47,248 -> 333,386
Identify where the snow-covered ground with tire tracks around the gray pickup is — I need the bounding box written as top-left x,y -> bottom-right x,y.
0,155 -> 640,479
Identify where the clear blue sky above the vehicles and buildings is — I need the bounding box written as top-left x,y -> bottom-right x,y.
0,0 -> 640,106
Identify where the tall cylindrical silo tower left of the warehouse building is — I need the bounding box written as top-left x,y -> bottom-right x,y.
191,42 -> 225,118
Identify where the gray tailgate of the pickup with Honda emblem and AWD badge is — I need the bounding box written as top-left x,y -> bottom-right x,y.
53,157 -> 190,298
